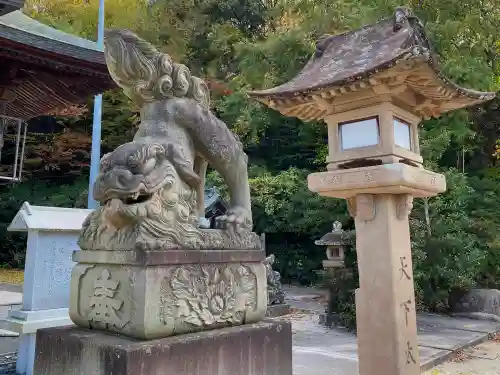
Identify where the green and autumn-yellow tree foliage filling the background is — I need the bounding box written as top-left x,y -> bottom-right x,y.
0,0 -> 500,323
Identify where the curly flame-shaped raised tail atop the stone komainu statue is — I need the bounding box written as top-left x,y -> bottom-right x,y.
104,29 -> 210,108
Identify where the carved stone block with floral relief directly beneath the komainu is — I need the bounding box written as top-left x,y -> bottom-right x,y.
70,250 -> 267,340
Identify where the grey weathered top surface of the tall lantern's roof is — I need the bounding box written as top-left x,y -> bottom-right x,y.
249,8 -> 495,100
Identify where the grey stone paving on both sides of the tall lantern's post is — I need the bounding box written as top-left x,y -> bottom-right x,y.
286,286 -> 500,375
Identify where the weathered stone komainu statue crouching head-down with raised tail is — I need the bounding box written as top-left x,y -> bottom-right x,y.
79,30 -> 260,250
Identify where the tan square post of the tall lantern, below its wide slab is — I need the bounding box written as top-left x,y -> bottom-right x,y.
351,194 -> 420,375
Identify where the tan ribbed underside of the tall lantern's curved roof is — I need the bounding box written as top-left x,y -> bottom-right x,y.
251,59 -> 495,121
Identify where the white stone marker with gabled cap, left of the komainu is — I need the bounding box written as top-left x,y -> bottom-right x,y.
7,202 -> 92,375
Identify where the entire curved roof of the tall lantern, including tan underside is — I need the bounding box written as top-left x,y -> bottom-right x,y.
249,7 -> 495,120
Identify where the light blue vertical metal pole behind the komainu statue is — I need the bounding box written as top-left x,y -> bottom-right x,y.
88,0 -> 104,209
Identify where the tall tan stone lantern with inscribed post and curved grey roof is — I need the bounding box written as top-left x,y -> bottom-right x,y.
250,8 -> 495,375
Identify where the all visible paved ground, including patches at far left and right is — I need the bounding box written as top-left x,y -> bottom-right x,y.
0,284 -> 500,375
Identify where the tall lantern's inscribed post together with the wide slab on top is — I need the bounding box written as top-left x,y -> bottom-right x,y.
308,163 -> 446,375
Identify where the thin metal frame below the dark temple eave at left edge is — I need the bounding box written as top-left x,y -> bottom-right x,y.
0,115 -> 28,183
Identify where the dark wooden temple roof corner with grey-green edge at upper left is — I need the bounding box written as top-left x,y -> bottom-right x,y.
0,12 -> 116,120
